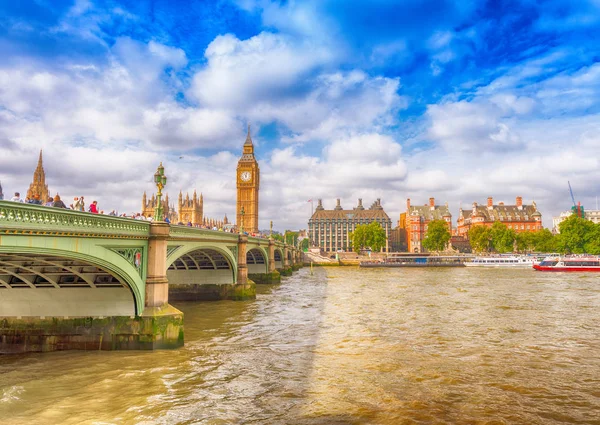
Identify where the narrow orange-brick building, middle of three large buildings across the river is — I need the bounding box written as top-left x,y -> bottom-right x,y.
398,198 -> 452,252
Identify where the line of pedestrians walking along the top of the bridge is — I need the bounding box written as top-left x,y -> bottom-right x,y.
2,192 -> 268,238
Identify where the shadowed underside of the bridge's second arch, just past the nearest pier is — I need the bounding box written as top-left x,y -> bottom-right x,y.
167,248 -> 235,285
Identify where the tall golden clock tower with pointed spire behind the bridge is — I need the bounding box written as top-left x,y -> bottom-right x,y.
236,125 -> 260,233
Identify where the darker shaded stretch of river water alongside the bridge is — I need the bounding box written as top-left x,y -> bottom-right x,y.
0,268 -> 373,425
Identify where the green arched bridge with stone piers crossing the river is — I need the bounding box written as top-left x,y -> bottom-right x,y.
0,201 -> 302,353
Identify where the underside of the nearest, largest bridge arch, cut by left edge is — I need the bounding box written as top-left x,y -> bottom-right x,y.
0,252 -> 136,317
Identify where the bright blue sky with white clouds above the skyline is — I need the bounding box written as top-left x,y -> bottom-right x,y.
0,0 -> 600,230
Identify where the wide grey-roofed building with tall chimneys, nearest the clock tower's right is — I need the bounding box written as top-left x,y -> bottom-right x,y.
308,199 -> 392,252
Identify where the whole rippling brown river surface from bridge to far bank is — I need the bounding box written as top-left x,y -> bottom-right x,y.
0,268 -> 600,425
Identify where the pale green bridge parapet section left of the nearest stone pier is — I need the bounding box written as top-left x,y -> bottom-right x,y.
0,201 -> 150,239
